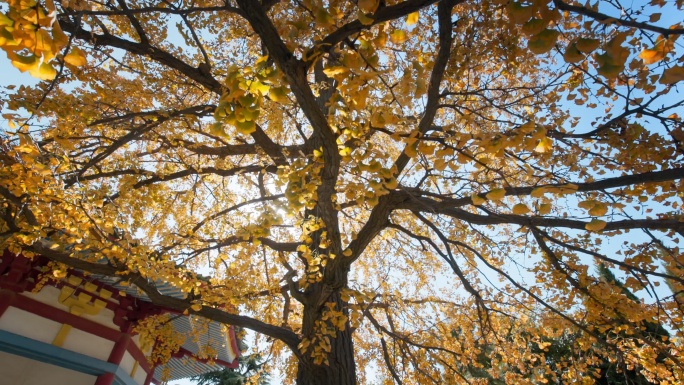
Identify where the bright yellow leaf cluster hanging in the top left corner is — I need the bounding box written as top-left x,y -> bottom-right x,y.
0,0 -> 86,80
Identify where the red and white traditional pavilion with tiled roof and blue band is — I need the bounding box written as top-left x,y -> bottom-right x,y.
0,251 -> 239,385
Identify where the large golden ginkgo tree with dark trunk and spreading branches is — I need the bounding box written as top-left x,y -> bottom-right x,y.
0,0 -> 684,384
